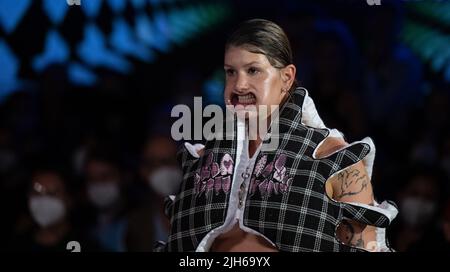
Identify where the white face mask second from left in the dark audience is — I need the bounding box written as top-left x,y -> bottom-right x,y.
87,181 -> 120,208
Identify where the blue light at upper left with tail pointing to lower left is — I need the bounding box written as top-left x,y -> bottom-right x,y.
32,30 -> 69,72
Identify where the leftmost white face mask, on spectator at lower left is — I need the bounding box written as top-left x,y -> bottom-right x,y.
28,196 -> 66,227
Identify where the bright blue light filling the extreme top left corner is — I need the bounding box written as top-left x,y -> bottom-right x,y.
0,0 -> 31,33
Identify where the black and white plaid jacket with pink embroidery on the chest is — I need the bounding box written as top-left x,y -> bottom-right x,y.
165,88 -> 396,252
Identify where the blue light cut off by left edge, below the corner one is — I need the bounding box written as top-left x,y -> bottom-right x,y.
0,40 -> 21,102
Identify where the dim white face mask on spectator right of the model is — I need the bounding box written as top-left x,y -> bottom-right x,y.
400,197 -> 435,227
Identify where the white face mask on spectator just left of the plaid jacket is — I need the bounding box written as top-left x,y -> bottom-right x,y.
149,166 -> 183,196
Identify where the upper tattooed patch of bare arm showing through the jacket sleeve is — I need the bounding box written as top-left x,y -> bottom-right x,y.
338,169 -> 369,198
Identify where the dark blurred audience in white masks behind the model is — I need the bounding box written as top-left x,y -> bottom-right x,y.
0,0 -> 450,252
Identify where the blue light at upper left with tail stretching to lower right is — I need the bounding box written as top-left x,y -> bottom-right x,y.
77,24 -> 132,73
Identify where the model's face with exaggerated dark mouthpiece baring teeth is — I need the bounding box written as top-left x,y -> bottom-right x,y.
224,46 -> 295,116
